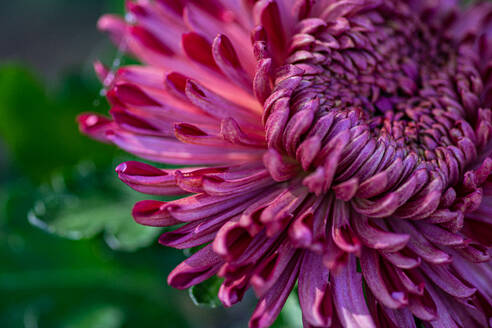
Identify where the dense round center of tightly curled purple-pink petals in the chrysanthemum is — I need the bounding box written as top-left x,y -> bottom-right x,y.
265,2 -> 483,199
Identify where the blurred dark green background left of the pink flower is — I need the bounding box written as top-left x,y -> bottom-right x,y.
0,0 -> 306,328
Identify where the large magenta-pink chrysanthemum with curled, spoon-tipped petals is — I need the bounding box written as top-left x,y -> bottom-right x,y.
79,0 -> 492,328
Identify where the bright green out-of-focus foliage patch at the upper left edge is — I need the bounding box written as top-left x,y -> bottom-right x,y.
0,65 -> 115,181
